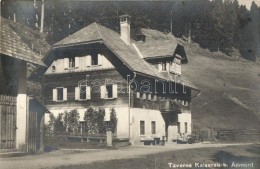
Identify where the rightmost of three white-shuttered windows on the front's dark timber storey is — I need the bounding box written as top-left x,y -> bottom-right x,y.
100,84 -> 117,99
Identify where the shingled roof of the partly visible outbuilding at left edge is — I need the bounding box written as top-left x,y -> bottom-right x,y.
0,17 -> 45,66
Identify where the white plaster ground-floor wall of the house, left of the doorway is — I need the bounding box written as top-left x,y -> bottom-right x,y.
45,107 -> 165,143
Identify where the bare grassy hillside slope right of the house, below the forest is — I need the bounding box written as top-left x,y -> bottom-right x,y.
181,40 -> 260,129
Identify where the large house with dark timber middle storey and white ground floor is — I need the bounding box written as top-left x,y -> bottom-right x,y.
34,15 -> 199,143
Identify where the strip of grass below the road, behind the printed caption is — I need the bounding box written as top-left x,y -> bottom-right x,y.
54,144 -> 260,169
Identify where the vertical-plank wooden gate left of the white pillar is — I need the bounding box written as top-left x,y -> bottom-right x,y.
0,95 -> 16,149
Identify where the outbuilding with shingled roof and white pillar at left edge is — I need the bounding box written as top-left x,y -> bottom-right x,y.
0,17 -> 48,153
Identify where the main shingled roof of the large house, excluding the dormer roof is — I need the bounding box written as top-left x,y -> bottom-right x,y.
54,22 -> 169,80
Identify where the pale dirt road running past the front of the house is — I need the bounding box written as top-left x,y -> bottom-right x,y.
0,143 -> 252,169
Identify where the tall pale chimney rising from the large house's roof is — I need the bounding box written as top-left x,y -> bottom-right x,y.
119,15 -> 131,45
